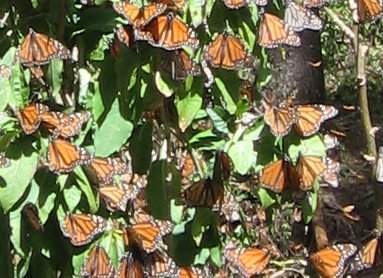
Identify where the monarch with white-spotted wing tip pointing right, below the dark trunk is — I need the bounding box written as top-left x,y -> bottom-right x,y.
294,104 -> 338,137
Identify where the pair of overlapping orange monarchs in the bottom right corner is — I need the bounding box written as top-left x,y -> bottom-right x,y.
309,237 -> 380,278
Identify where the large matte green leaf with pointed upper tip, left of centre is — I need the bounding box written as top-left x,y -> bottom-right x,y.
94,98 -> 133,157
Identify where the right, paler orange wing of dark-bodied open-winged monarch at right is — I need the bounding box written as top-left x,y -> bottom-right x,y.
295,155 -> 326,191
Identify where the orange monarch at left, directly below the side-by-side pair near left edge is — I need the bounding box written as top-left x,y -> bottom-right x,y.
48,139 -> 91,173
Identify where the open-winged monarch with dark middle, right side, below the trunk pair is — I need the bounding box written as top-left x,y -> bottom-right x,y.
259,155 -> 326,193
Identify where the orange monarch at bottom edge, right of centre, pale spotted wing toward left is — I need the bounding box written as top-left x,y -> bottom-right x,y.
224,244 -> 270,277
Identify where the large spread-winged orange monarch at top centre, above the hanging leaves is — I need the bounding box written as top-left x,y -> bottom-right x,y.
135,12 -> 199,50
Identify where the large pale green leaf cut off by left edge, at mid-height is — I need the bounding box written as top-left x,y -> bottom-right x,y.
0,141 -> 39,212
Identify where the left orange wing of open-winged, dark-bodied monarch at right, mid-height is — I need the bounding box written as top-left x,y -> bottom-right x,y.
259,159 -> 290,193
